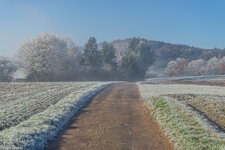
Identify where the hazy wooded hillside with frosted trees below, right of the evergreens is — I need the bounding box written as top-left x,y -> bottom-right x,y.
112,39 -> 225,78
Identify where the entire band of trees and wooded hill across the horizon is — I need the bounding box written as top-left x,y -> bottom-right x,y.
0,33 -> 225,81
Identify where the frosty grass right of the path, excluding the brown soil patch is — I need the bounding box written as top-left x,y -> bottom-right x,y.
138,84 -> 225,150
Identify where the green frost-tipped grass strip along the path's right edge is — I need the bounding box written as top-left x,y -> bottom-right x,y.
141,96 -> 225,150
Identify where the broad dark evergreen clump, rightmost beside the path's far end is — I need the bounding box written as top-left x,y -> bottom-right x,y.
120,38 -> 154,80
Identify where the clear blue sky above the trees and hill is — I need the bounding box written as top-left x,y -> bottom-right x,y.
0,0 -> 225,56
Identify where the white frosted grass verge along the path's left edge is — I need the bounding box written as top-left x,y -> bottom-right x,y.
0,82 -> 112,150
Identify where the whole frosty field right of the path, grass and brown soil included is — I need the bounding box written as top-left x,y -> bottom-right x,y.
138,83 -> 225,150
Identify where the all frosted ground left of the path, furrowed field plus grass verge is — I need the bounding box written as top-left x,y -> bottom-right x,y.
0,82 -> 112,150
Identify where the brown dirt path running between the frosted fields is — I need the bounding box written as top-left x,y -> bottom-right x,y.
47,83 -> 173,150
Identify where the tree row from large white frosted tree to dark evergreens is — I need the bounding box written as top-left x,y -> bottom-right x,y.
1,33 -> 154,81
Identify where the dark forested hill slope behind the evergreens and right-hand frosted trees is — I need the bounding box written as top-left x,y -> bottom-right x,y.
111,38 -> 225,68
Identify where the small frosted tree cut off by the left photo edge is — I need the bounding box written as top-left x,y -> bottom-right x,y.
0,57 -> 16,82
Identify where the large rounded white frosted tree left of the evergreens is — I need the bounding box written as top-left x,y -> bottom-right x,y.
17,33 -> 78,81
